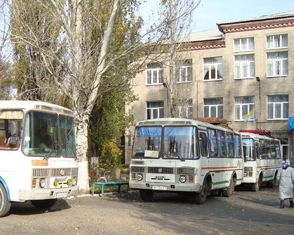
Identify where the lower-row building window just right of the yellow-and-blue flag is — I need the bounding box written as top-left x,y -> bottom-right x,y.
267,95 -> 289,120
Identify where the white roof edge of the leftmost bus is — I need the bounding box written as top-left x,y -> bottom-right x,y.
0,100 -> 72,115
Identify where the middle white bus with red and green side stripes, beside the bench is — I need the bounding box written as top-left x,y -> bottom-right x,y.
129,118 -> 243,204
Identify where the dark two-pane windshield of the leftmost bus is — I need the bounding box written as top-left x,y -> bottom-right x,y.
23,111 -> 75,158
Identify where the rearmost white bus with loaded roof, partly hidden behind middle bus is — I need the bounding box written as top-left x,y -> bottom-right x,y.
240,130 -> 282,192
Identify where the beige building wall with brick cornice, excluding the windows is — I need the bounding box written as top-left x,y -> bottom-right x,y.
126,11 -> 294,163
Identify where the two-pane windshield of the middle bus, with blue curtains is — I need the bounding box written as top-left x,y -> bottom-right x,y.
133,126 -> 196,159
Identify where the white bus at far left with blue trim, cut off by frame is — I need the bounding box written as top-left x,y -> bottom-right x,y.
0,100 -> 78,217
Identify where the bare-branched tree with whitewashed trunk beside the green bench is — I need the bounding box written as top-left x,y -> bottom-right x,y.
10,0 -> 200,193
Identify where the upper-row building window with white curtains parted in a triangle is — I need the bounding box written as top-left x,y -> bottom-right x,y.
204,57 -> 223,80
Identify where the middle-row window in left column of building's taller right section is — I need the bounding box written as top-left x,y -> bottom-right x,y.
235,55 -> 255,78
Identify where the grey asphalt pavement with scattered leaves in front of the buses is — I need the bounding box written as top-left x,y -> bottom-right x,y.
0,188 -> 294,235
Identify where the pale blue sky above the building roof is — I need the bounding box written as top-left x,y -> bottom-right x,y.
141,0 -> 294,32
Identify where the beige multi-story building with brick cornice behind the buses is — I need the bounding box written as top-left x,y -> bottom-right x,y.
125,11 -> 294,163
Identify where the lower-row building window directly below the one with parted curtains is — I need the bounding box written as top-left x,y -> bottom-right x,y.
204,98 -> 223,118
